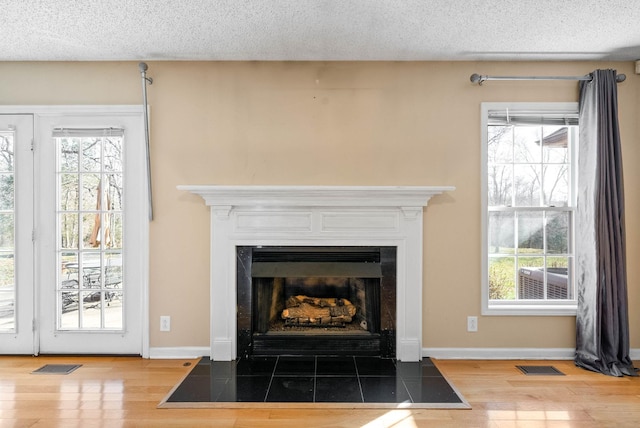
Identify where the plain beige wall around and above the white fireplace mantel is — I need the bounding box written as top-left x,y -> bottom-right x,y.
0,62 -> 640,348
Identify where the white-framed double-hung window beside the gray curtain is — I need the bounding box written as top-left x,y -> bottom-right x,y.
482,103 -> 578,315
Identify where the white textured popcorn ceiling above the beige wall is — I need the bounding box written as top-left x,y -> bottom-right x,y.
0,0 -> 640,61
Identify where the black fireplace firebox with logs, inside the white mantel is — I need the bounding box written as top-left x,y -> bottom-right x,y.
237,246 -> 396,358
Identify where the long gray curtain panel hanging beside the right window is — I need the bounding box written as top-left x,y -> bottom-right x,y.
575,70 -> 637,376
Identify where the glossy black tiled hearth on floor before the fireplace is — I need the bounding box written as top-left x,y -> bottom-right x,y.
161,356 -> 468,408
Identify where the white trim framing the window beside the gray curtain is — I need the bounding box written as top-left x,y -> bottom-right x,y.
480,102 -> 578,316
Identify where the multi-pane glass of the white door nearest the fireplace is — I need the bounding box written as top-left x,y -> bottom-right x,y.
54,128 -> 125,330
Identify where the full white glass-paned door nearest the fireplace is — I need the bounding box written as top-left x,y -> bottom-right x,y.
36,114 -> 148,354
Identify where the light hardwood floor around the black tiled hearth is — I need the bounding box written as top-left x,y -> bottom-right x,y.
0,356 -> 640,428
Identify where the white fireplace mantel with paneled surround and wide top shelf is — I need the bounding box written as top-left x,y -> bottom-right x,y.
178,185 -> 455,361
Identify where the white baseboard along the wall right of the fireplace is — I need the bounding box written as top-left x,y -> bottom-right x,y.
422,348 -> 640,361
